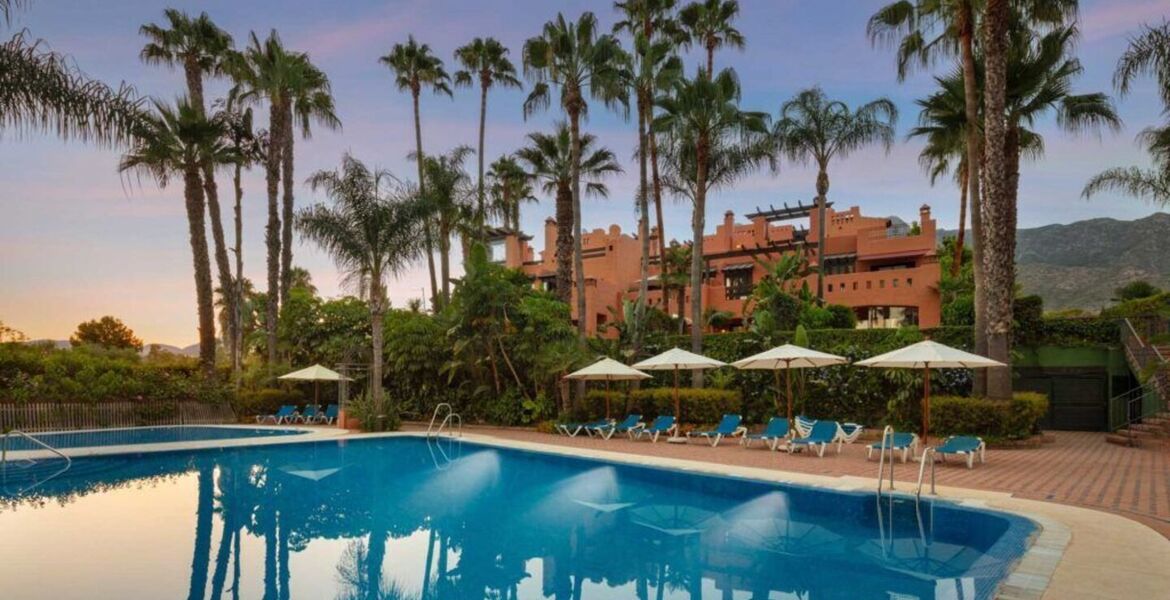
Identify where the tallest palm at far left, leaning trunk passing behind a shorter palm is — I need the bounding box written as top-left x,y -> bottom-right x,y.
138,8 -> 235,354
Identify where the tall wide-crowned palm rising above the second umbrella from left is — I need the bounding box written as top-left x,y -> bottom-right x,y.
524,12 -> 628,343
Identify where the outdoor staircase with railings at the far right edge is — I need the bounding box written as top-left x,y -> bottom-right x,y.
1106,318 -> 1170,447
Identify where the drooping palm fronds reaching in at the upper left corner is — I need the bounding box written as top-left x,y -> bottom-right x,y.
0,0 -> 145,146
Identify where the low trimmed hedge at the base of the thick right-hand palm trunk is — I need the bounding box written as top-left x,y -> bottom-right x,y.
930,392 -> 1048,440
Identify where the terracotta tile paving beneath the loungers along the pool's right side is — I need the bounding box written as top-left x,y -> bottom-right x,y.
407,426 -> 1170,538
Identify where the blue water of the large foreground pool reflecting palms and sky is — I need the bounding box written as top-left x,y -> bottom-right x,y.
0,437 -> 1034,600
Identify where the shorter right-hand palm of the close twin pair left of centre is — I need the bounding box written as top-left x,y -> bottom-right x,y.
281,53 -> 342,304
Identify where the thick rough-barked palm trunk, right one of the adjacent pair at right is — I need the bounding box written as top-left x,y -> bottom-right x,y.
983,0 -> 1016,400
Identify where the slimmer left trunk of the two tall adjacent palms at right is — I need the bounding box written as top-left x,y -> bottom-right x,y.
958,0 -> 987,395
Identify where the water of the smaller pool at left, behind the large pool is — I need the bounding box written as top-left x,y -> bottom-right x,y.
0,425 -> 305,450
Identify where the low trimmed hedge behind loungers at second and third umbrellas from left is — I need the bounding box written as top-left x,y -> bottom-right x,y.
578,387 -> 743,426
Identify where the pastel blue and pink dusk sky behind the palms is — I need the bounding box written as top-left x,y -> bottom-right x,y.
0,0 -> 1170,345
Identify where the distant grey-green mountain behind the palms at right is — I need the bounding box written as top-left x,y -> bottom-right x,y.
940,213 -> 1170,310
